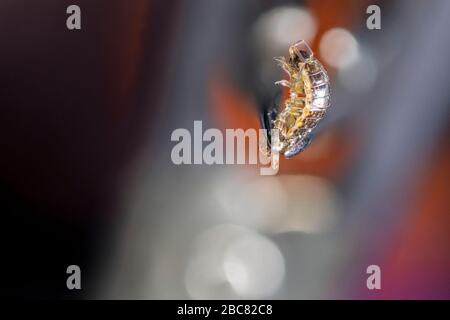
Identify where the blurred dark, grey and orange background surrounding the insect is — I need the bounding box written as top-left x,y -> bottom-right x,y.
0,0 -> 450,299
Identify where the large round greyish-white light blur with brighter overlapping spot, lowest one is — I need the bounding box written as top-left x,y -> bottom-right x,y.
185,224 -> 285,299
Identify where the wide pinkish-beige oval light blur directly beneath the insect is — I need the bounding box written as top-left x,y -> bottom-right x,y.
214,175 -> 340,233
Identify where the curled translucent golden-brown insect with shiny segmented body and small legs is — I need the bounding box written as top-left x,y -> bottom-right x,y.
274,40 -> 330,158
